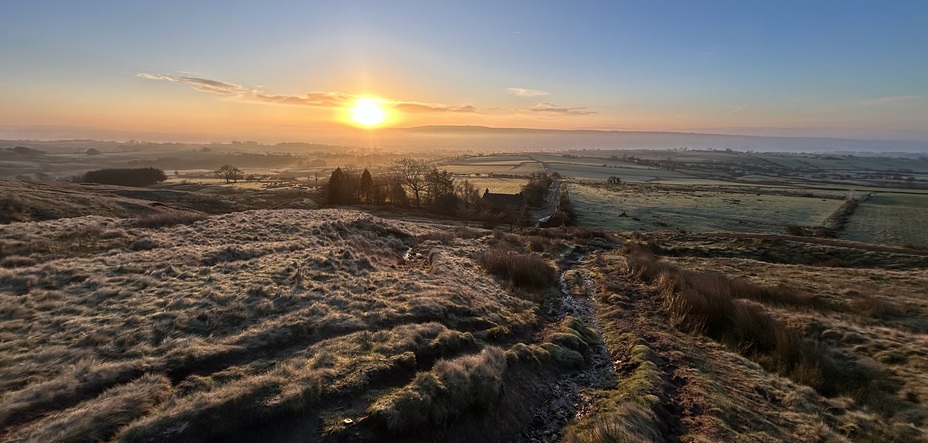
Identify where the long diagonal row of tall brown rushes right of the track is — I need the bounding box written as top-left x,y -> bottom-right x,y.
627,243 -> 912,415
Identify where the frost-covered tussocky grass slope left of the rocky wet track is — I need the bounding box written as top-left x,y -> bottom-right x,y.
0,210 -> 600,441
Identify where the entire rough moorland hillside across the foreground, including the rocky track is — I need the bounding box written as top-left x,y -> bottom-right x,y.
0,182 -> 928,442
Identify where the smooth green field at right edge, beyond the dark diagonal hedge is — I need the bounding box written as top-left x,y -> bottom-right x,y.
842,192 -> 928,246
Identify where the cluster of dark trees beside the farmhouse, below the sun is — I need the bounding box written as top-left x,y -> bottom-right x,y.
327,158 -> 487,218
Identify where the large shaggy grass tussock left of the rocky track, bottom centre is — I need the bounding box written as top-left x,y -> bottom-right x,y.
369,347 -> 507,433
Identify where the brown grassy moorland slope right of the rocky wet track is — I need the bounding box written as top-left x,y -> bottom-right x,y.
566,235 -> 928,442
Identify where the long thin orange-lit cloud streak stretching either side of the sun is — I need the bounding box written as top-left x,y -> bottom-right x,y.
137,72 -> 478,114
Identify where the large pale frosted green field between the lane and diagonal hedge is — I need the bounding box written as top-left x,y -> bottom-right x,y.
570,184 -> 844,233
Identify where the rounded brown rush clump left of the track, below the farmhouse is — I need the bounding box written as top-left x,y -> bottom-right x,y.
479,248 -> 558,289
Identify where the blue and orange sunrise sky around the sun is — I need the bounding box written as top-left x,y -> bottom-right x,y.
0,0 -> 928,142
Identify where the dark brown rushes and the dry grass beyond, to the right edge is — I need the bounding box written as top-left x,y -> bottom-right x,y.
604,241 -> 928,441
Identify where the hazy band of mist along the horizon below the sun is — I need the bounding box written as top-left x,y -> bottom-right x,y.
7,126 -> 928,153
